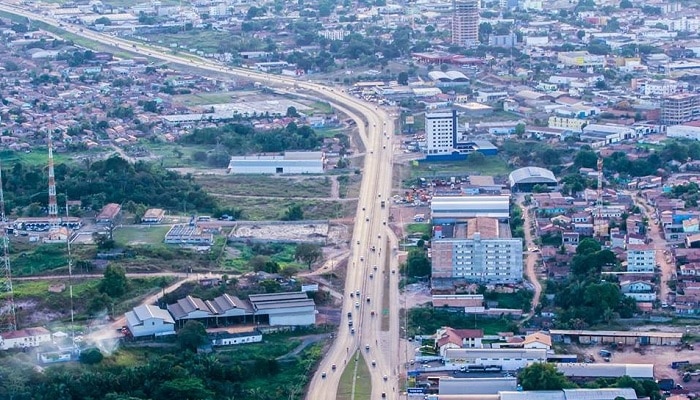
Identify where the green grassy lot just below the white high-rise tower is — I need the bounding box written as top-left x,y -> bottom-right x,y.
410,156 -> 511,180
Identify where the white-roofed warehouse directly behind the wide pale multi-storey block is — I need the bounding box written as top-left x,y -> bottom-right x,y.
430,195 -> 510,224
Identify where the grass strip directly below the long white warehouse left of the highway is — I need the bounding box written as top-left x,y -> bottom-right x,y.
195,175 -> 331,198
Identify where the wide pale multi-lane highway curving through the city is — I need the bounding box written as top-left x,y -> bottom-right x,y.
0,4 -> 400,400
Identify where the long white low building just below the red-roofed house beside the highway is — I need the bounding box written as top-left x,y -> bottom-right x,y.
444,349 -> 547,371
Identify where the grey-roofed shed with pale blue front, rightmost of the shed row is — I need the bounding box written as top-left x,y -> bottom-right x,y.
248,292 -> 316,326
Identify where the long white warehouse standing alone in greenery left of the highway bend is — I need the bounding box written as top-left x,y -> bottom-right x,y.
228,151 -> 326,174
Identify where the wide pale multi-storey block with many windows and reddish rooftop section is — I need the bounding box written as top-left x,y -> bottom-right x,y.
432,218 -> 523,288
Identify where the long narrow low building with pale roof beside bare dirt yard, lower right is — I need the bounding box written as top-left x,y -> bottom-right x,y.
549,329 -> 683,346
